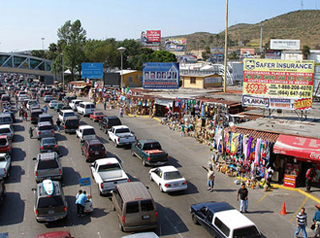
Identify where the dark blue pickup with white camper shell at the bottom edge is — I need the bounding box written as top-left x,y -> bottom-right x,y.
190,202 -> 262,238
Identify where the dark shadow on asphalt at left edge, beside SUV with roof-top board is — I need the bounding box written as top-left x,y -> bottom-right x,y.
0,192 -> 25,226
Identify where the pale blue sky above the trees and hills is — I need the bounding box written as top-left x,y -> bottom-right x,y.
0,0 -> 320,52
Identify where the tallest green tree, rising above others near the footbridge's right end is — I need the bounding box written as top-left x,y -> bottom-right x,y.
58,20 -> 87,80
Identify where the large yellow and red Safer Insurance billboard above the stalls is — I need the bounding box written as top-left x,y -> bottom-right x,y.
242,59 -> 314,110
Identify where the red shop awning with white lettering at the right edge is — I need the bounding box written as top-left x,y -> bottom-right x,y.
273,135 -> 320,162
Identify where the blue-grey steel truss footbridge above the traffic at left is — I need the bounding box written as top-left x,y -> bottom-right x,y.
0,53 -> 53,76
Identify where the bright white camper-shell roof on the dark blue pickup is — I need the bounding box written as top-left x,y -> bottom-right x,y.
215,209 -> 255,230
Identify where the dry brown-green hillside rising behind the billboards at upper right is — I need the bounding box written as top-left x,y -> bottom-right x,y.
165,10 -> 320,50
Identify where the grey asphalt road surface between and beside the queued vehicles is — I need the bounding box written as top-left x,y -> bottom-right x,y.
0,98 -> 314,238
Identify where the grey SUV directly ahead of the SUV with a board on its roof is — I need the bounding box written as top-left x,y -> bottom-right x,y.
33,152 -> 62,182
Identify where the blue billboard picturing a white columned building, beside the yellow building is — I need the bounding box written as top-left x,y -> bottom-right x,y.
142,63 -> 179,89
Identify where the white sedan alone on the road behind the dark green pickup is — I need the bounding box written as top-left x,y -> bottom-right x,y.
149,165 -> 188,193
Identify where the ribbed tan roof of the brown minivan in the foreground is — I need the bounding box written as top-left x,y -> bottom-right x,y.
117,182 -> 152,201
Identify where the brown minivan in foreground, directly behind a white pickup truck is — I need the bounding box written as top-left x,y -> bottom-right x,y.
112,182 -> 158,231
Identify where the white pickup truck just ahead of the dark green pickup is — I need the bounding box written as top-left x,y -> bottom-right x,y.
108,126 -> 136,147
